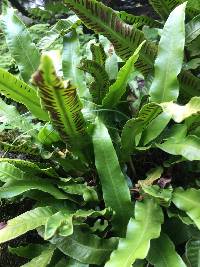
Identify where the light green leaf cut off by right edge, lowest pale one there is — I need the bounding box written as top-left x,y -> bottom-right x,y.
172,188 -> 200,229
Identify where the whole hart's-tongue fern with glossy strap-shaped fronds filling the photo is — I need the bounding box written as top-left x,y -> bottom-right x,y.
0,0 -> 200,267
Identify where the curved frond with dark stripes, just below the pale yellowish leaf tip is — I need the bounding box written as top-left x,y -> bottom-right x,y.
121,103 -> 162,157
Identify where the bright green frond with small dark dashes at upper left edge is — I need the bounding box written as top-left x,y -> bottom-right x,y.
0,69 -> 49,121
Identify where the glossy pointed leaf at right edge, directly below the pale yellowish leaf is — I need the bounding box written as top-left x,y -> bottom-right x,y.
156,135 -> 200,161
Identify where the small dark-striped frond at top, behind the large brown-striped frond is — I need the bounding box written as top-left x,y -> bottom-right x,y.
118,11 -> 161,28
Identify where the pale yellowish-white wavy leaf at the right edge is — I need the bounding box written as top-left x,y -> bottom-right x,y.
161,97 -> 200,123
